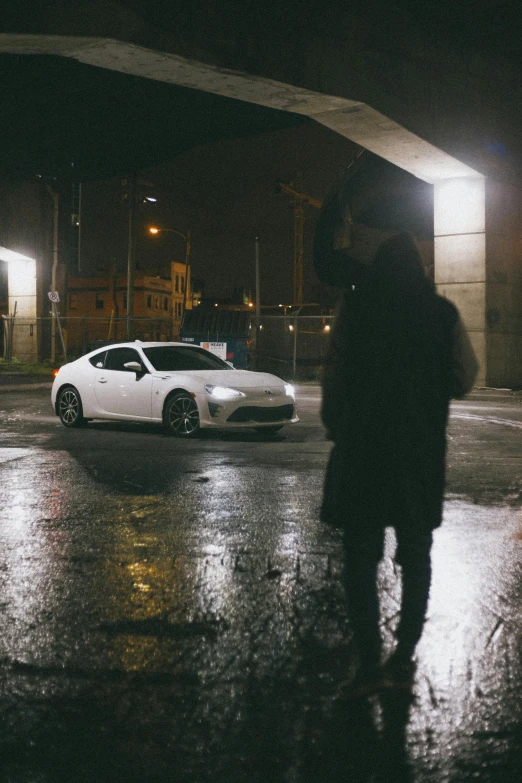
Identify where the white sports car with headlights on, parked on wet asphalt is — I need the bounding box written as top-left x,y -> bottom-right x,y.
51,340 -> 298,438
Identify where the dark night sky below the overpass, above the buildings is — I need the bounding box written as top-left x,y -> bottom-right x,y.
77,123 -> 356,303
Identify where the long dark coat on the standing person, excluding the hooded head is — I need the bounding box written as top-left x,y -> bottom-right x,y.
322,284 -> 458,530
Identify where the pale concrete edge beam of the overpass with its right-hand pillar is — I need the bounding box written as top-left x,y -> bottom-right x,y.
0,35 -> 522,386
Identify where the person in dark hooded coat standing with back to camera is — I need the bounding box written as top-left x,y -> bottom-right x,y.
314,188 -> 478,697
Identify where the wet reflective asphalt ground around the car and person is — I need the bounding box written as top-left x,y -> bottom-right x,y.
0,386 -> 522,783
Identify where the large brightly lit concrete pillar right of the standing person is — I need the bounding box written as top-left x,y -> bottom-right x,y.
434,177 -> 522,387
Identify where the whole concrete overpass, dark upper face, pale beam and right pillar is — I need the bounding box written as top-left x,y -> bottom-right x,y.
0,0 -> 522,386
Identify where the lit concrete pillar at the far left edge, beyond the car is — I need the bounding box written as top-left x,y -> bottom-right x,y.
7,254 -> 38,364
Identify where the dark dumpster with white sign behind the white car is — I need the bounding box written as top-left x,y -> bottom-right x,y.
179,309 -> 252,370
